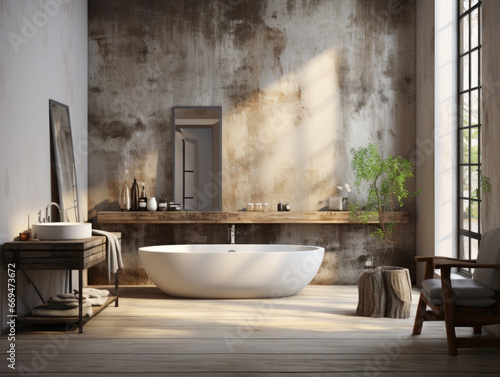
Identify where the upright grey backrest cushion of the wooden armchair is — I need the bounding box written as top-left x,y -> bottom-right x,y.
473,229 -> 500,291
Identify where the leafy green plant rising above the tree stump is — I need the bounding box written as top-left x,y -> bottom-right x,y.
349,144 -> 420,244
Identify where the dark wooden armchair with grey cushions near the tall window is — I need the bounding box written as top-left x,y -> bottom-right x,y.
413,229 -> 500,356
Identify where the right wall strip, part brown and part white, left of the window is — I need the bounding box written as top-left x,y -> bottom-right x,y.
415,0 -> 457,284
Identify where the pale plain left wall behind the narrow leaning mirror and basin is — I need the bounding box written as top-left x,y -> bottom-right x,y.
0,0 -> 88,330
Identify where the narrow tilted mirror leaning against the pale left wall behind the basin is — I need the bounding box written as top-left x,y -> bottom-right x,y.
49,100 -> 80,222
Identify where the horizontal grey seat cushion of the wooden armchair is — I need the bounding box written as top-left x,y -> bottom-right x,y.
422,279 -> 496,308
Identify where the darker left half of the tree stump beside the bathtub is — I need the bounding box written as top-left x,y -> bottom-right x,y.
356,268 -> 387,318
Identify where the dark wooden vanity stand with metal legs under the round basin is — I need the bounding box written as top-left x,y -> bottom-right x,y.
4,236 -> 118,333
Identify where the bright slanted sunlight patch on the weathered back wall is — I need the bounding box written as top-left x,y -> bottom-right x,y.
223,50 -> 342,210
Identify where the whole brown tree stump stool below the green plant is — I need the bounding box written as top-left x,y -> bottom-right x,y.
356,266 -> 411,318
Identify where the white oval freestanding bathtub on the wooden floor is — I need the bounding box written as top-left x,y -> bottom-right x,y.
139,244 -> 325,298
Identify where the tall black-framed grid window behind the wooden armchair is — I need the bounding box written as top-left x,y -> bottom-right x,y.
457,0 -> 481,272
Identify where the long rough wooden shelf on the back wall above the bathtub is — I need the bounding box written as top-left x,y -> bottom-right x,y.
97,211 -> 409,224
